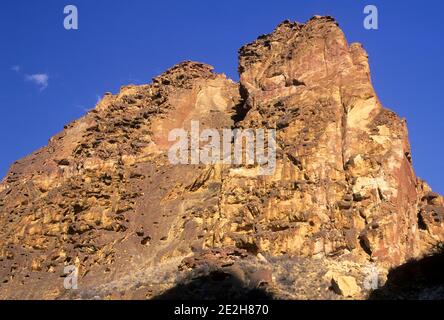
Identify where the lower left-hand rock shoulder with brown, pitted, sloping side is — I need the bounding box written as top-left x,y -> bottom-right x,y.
0,62 -> 239,298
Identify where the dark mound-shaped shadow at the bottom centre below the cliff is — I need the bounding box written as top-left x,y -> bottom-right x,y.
153,271 -> 273,300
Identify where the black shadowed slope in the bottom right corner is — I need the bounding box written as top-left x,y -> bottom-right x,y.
369,246 -> 444,300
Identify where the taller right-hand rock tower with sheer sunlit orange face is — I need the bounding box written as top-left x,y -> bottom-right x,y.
222,17 -> 420,265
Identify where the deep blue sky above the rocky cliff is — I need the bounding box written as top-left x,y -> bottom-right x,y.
0,0 -> 444,193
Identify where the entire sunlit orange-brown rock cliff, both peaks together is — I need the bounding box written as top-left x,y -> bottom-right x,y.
0,17 -> 444,299
